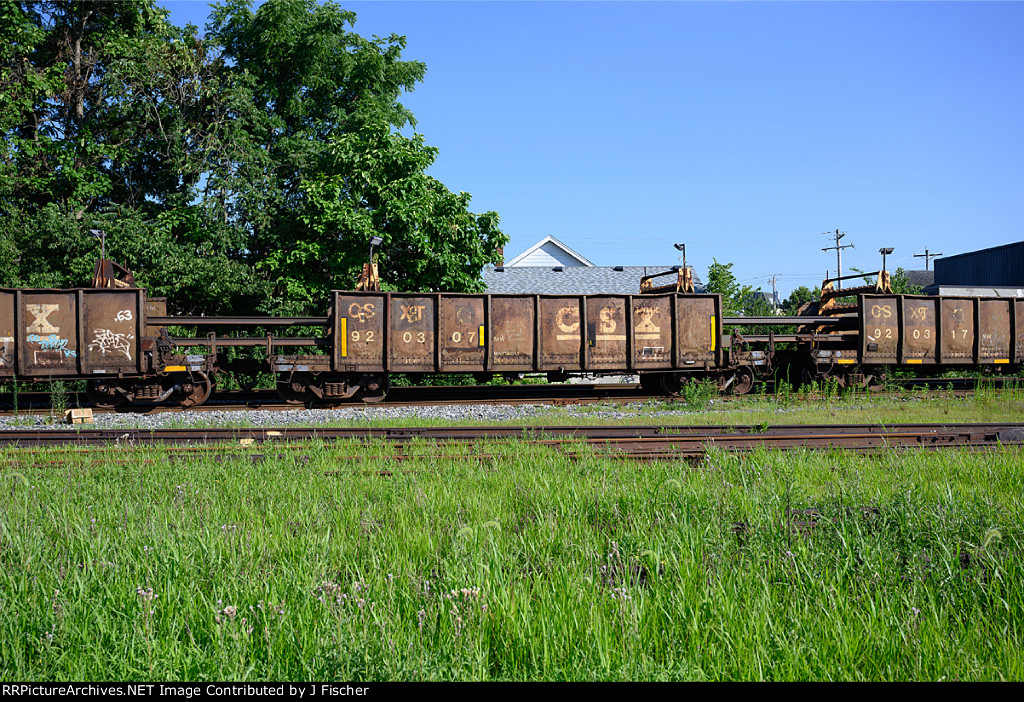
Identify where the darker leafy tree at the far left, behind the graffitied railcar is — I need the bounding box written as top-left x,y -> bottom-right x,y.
0,0 -> 257,311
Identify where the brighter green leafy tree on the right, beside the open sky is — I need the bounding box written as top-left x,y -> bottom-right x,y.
209,0 -> 507,311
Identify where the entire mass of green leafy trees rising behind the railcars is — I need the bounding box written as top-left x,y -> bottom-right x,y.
0,0 -> 507,313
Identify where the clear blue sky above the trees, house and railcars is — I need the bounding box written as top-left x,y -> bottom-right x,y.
160,0 -> 1024,295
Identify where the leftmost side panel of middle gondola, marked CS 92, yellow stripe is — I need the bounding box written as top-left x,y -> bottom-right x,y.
334,293 -> 387,372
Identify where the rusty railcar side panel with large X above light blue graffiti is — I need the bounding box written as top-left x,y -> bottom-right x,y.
15,291 -> 80,377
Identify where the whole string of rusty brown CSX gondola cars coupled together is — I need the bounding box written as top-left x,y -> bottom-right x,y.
0,288 -> 1024,406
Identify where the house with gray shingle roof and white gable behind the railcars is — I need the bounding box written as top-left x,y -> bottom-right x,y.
483,236 -> 705,295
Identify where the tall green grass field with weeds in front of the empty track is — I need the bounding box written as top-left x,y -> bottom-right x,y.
0,425 -> 1024,681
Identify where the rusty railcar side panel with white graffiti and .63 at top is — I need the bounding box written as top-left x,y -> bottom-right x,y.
79,290 -> 145,375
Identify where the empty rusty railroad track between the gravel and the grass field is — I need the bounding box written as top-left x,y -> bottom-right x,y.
0,424 -> 1024,459
